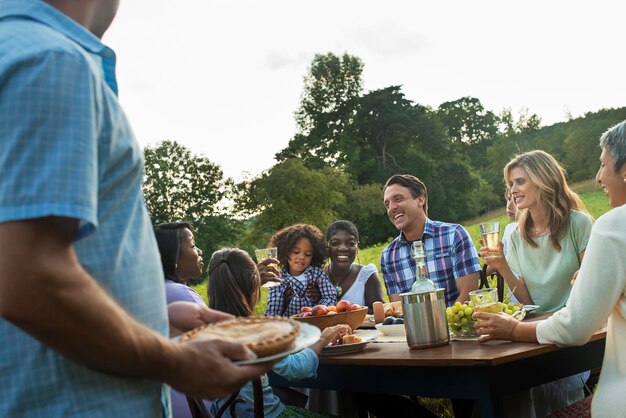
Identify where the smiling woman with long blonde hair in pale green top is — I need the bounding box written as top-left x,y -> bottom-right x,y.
481,150 -> 592,312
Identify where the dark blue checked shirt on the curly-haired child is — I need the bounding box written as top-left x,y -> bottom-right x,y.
265,266 -> 337,316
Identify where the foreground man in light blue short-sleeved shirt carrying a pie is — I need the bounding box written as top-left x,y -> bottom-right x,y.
0,0 -> 270,418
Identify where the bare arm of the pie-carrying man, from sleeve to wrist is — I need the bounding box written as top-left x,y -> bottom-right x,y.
0,219 -> 177,378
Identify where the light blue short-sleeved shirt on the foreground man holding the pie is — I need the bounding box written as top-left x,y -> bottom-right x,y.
0,0 -> 169,418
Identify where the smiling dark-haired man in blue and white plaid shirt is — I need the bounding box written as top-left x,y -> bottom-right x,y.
380,174 -> 481,305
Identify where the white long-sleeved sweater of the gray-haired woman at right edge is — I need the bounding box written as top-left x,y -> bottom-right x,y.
537,205 -> 626,417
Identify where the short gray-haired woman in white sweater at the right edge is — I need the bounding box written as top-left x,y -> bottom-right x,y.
474,121 -> 626,417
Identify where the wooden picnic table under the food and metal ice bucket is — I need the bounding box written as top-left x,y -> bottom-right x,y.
270,328 -> 606,418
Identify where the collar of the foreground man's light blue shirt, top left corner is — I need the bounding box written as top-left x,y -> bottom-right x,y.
0,0 -> 117,96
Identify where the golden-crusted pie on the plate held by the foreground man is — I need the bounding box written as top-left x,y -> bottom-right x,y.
180,316 -> 300,357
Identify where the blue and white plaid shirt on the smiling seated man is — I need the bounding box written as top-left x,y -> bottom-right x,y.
380,218 -> 481,306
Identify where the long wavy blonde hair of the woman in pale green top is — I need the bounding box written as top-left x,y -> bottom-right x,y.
504,150 -> 591,251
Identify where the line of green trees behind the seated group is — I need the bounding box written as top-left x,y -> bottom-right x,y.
144,53 -> 626,264
